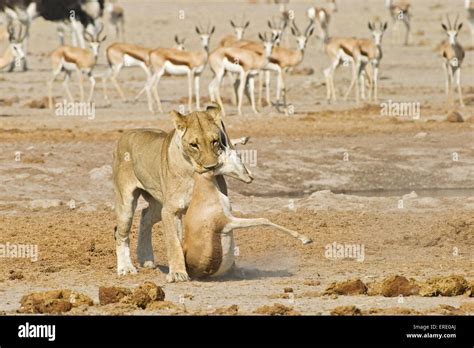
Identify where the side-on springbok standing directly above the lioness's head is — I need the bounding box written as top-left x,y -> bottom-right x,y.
137,25 -> 216,113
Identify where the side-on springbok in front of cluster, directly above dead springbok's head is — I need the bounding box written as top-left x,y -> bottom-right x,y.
209,33 -> 277,115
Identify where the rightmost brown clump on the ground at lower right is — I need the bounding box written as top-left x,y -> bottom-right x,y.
419,275 -> 470,297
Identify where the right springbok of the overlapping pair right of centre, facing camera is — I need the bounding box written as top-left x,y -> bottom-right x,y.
344,22 -> 388,102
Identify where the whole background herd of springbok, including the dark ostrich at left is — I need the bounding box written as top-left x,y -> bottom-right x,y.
0,0 -> 474,115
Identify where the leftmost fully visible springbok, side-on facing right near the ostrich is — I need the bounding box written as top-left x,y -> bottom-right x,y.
48,26 -> 106,109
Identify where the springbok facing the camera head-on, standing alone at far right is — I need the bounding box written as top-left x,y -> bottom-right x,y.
438,16 -> 465,106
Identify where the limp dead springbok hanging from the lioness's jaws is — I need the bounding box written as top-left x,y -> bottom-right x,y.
183,132 -> 311,278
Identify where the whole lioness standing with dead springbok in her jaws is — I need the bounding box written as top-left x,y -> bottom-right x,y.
113,106 -> 226,282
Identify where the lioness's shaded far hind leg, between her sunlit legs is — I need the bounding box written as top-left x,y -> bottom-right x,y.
137,193 -> 163,268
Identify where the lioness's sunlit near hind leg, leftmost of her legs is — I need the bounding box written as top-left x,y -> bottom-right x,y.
115,186 -> 140,275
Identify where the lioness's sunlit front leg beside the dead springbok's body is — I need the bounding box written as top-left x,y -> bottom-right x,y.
161,209 -> 189,283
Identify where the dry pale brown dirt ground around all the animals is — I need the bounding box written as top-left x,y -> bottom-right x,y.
0,0 -> 474,314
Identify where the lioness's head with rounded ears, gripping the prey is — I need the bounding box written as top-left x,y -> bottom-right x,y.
171,105 -> 222,173
